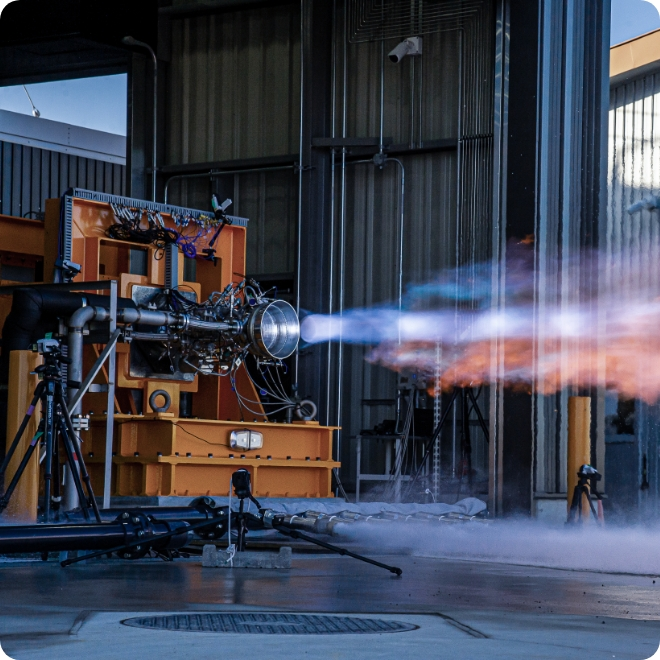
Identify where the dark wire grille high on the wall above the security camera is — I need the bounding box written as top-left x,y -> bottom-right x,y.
348,0 -> 483,43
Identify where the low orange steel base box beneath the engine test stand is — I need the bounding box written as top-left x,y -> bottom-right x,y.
83,413 -> 340,497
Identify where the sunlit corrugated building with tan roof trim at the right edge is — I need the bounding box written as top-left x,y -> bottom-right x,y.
599,30 -> 660,517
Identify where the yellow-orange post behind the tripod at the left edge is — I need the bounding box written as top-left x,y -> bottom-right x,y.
5,351 -> 41,522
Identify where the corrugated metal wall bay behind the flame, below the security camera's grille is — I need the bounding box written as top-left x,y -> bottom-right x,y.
331,3 -> 494,490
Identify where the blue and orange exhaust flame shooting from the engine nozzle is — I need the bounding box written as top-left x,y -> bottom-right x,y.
302,245 -> 660,403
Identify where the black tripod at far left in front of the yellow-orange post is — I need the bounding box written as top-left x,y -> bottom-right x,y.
0,339 -> 101,522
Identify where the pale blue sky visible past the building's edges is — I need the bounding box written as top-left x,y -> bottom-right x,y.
0,0 -> 660,135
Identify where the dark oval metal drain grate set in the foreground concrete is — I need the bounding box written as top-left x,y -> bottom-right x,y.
122,612 -> 417,635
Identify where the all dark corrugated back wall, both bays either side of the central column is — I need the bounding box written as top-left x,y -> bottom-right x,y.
167,2 -> 495,496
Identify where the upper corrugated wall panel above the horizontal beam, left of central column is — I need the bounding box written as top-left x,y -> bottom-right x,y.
166,5 -> 300,164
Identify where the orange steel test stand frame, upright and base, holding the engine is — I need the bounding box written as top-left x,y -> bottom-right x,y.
31,198 -> 340,497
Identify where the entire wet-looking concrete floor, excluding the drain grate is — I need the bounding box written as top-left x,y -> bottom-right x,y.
0,554 -> 660,660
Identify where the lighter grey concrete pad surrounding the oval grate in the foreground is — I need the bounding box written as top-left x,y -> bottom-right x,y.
5,612 -> 657,660
